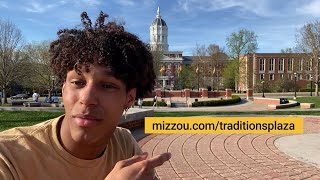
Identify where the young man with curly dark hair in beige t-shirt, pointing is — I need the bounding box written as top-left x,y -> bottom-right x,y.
0,13 -> 170,180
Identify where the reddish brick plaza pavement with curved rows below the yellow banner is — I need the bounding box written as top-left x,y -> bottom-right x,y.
139,117 -> 320,180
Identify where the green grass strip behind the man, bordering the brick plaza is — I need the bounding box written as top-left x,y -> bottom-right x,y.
0,111 -> 320,131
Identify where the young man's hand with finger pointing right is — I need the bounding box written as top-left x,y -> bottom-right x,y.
105,152 -> 171,180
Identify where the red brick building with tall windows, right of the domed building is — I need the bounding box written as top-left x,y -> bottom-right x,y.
239,53 -> 312,91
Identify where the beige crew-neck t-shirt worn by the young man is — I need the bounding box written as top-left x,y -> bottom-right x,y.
0,116 -> 142,180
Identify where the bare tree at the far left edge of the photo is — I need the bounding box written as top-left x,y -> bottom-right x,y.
0,20 -> 27,103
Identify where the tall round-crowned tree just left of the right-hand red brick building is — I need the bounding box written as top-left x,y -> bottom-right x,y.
226,29 -> 258,92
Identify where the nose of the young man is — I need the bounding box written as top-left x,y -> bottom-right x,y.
80,83 -> 98,106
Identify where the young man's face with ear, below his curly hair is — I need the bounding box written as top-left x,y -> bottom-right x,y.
62,64 -> 136,145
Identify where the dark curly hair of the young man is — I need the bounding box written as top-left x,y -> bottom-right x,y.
49,12 -> 156,97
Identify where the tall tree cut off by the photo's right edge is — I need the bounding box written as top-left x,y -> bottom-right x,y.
296,21 -> 320,96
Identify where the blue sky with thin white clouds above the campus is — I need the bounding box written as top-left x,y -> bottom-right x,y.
0,0 -> 320,56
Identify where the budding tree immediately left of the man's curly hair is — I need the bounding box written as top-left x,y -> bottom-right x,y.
24,41 -> 59,99
